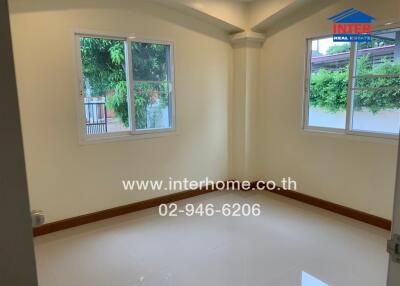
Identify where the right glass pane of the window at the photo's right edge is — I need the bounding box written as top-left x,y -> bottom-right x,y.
352,30 -> 400,134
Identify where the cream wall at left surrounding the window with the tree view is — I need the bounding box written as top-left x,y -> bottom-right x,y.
10,0 -> 233,222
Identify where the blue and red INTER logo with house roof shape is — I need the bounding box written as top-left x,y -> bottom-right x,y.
329,8 -> 375,42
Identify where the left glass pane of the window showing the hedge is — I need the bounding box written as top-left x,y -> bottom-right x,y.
308,37 -> 351,129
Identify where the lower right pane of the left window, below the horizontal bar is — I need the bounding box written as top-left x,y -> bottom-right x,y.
135,81 -> 171,130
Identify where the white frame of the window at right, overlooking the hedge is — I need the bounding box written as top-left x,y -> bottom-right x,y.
302,27 -> 400,141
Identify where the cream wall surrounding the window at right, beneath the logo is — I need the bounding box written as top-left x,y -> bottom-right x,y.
252,0 -> 400,218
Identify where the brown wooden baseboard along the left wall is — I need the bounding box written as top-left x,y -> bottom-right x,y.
33,183 -> 222,236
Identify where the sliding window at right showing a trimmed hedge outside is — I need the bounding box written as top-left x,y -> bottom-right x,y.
304,29 -> 400,137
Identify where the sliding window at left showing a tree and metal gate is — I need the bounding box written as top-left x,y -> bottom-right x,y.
76,34 -> 174,140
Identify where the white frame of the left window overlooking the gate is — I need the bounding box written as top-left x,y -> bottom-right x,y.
74,30 -> 176,144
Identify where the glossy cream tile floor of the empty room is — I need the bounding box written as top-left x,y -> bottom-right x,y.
35,191 -> 389,286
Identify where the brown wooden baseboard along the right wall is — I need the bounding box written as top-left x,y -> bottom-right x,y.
251,182 -> 392,231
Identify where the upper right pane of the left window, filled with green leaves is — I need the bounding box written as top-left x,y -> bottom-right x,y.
132,42 -> 170,81
